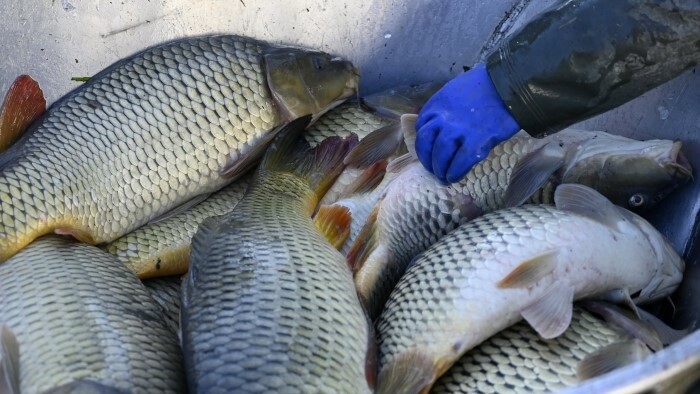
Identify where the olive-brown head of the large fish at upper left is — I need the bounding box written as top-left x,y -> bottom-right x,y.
264,48 -> 360,121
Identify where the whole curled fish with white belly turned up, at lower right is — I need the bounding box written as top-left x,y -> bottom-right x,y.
378,185 -> 684,393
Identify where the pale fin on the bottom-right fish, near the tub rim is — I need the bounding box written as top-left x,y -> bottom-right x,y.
576,339 -> 651,380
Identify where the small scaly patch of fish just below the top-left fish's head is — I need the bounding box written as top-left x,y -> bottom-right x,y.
304,103 -> 396,146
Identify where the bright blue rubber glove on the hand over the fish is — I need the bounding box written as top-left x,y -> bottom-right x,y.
416,64 -> 520,183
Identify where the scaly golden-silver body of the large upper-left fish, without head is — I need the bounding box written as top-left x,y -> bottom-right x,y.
0,36 -> 281,258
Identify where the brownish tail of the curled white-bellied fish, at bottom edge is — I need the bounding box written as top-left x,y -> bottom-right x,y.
377,350 -> 437,394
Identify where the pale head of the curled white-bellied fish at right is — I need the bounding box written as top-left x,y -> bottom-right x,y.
616,207 -> 685,304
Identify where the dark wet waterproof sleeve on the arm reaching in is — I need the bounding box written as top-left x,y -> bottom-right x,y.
487,0 -> 700,136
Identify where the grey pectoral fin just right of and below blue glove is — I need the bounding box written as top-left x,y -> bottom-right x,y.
504,143 -> 566,207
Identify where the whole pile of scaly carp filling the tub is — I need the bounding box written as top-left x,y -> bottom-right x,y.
0,35 -> 700,393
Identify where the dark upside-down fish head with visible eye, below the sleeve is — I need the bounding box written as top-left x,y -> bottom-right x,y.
562,132 -> 693,212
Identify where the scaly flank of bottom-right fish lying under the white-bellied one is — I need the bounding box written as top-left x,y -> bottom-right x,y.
431,307 -> 629,394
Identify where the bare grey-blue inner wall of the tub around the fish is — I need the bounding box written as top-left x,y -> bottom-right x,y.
0,0 -> 700,388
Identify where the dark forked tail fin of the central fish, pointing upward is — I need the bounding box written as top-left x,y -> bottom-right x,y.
260,115 -> 357,199
